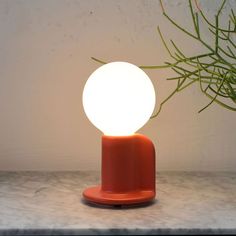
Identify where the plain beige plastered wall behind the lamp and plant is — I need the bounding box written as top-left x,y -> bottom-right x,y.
0,0 -> 236,171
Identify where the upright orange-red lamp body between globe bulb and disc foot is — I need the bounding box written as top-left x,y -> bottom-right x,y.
102,134 -> 155,193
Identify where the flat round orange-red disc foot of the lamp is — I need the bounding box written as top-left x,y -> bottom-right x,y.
83,186 -> 155,205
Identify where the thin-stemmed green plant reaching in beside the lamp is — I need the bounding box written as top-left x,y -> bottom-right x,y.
92,0 -> 236,118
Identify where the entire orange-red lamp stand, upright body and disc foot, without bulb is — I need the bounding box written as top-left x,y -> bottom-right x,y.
83,134 -> 156,205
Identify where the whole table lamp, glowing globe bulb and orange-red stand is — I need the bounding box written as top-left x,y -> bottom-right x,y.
83,62 -> 156,205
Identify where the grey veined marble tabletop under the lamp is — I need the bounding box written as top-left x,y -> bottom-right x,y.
0,172 -> 236,235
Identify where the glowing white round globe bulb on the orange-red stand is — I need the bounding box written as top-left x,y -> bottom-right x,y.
83,62 -> 156,136
